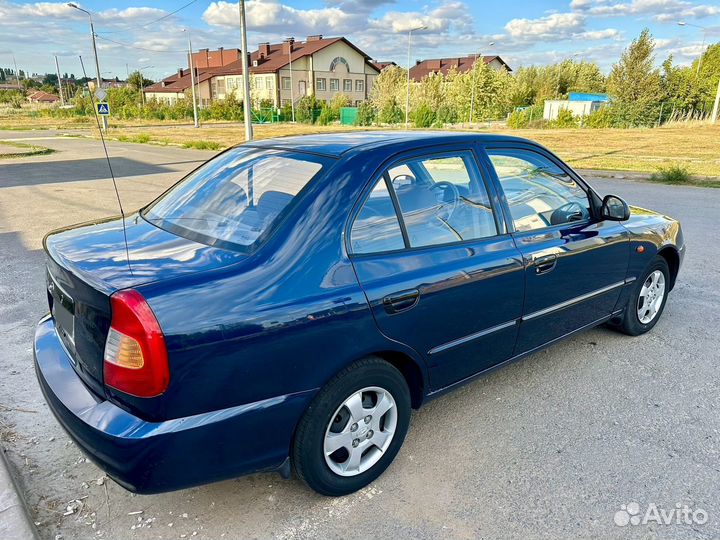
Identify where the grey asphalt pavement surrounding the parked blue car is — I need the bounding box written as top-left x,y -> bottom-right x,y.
0,132 -> 720,539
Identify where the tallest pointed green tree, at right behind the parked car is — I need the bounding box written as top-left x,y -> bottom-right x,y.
608,28 -> 664,127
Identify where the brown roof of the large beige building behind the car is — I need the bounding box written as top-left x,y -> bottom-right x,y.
145,36 -> 380,93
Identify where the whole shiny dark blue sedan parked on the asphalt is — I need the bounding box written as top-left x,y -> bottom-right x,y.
34,132 -> 685,495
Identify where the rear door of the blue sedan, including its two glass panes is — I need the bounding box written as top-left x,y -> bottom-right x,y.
348,146 -> 524,389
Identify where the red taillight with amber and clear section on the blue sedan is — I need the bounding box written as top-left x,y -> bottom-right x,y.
103,289 -> 170,397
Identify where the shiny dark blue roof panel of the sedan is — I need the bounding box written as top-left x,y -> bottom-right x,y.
245,130 -> 531,157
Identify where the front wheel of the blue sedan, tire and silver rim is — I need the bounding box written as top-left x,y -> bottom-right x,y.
619,256 -> 670,336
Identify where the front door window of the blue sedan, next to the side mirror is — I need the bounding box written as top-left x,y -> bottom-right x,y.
488,149 -> 590,231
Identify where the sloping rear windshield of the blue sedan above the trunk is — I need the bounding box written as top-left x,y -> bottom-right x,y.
142,147 -> 322,250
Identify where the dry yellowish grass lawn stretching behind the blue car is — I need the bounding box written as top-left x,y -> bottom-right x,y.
0,115 -> 720,181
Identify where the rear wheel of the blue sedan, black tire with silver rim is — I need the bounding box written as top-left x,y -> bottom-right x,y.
292,357 -> 411,496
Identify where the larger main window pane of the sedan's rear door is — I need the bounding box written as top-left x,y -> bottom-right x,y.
387,152 -> 497,247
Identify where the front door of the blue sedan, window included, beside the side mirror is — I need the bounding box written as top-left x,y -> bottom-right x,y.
486,145 -> 629,354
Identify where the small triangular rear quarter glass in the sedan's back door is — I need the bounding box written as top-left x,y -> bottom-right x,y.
350,178 -> 405,254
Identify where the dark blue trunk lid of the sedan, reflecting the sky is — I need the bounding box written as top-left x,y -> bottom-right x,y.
44,214 -> 246,395
